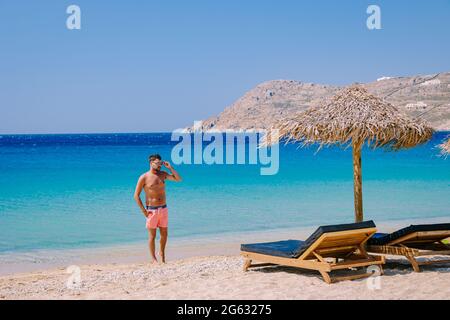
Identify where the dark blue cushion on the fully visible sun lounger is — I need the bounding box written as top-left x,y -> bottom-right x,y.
241,221 -> 375,258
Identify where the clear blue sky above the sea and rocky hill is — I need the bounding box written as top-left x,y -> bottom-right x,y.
0,0 -> 450,133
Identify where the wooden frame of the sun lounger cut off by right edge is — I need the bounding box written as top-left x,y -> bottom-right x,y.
367,230 -> 450,272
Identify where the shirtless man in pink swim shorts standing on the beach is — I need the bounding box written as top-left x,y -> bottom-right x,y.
134,154 -> 181,263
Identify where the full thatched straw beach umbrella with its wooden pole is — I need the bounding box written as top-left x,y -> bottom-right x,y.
262,85 -> 433,222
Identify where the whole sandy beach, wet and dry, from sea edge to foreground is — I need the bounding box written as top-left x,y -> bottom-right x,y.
0,220 -> 450,299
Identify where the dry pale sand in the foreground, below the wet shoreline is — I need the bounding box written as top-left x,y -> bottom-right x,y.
0,256 -> 450,299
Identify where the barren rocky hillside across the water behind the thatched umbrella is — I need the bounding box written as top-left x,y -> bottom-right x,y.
187,72 -> 450,131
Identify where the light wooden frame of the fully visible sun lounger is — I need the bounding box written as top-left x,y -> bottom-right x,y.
241,228 -> 385,283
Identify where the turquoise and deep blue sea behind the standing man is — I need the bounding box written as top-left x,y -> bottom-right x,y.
0,132 -> 450,253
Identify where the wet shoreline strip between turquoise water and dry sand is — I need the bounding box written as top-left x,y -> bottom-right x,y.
0,217 -> 450,277
